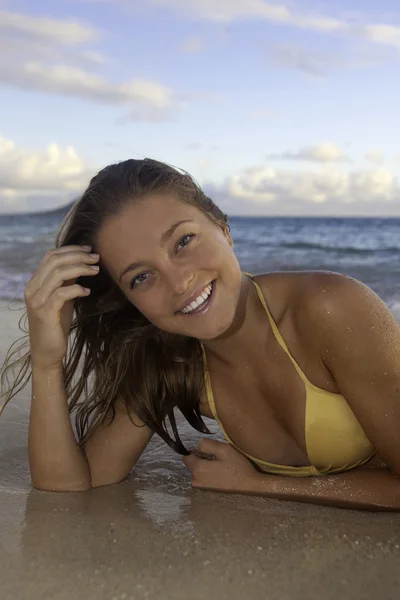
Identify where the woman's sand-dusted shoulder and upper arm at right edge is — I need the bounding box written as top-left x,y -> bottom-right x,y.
298,272 -> 400,476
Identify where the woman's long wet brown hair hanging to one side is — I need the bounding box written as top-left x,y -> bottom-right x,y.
0,158 -> 229,454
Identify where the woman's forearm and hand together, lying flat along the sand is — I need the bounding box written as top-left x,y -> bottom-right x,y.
182,438 -> 400,511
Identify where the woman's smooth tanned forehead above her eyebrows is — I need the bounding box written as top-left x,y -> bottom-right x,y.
97,194 -> 211,273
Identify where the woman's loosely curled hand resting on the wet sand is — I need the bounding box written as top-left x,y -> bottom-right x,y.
182,438 -> 260,492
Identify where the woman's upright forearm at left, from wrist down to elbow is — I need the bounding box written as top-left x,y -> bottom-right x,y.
28,365 -> 91,491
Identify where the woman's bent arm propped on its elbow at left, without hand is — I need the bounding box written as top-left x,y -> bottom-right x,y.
28,365 -> 152,492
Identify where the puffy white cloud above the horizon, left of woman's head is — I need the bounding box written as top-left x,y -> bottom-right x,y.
0,136 -> 94,213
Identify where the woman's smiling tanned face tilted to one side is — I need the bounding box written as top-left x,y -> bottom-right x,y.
97,194 -> 241,340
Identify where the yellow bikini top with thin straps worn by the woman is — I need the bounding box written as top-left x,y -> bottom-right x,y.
201,271 -> 375,477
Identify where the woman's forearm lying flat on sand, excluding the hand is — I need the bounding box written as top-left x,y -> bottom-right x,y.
247,468 -> 400,511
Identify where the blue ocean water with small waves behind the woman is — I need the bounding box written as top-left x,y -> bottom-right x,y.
0,204 -> 400,319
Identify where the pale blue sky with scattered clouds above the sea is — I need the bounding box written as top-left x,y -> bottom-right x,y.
0,0 -> 400,217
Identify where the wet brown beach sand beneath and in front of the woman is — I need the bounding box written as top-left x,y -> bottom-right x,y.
0,302 -> 400,600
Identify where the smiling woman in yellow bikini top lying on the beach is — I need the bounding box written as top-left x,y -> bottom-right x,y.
2,159 -> 400,510
